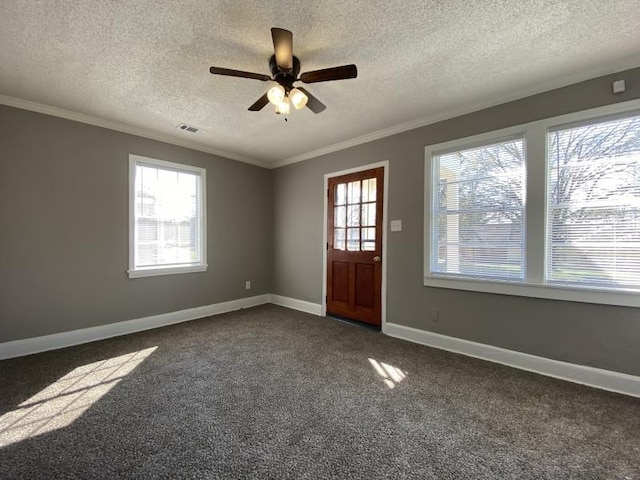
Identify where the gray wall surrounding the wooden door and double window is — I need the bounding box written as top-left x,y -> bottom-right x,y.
273,68 -> 640,375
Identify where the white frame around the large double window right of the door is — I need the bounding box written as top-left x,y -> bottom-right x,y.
423,100 -> 640,307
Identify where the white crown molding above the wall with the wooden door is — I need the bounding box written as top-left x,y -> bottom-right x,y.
267,56 -> 640,168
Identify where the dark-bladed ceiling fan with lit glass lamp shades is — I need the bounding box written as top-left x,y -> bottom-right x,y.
209,28 -> 358,115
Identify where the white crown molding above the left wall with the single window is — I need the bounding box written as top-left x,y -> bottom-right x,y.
0,95 -> 273,168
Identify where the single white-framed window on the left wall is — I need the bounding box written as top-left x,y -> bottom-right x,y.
128,155 -> 207,278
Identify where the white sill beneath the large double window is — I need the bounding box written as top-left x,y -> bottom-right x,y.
424,276 -> 640,307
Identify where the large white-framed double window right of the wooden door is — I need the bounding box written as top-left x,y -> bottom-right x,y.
424,100 -> 640,307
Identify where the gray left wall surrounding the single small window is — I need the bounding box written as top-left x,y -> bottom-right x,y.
0,106 -> 273,342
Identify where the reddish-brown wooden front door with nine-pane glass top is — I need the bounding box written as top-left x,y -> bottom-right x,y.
327,167 -> 384,325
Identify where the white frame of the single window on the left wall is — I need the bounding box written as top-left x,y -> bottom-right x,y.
127,154 -> 208,278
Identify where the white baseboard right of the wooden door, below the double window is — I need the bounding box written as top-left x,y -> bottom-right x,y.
384,323 -> 640,397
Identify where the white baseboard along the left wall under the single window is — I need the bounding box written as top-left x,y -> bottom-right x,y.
0,294 -> 271,360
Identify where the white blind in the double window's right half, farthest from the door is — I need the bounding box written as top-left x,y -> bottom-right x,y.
546,115 -> 640,289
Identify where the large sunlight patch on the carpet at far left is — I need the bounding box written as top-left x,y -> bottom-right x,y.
0,347 -> 158,447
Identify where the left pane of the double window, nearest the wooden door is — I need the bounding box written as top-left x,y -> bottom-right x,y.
431,136 -> 525,281
